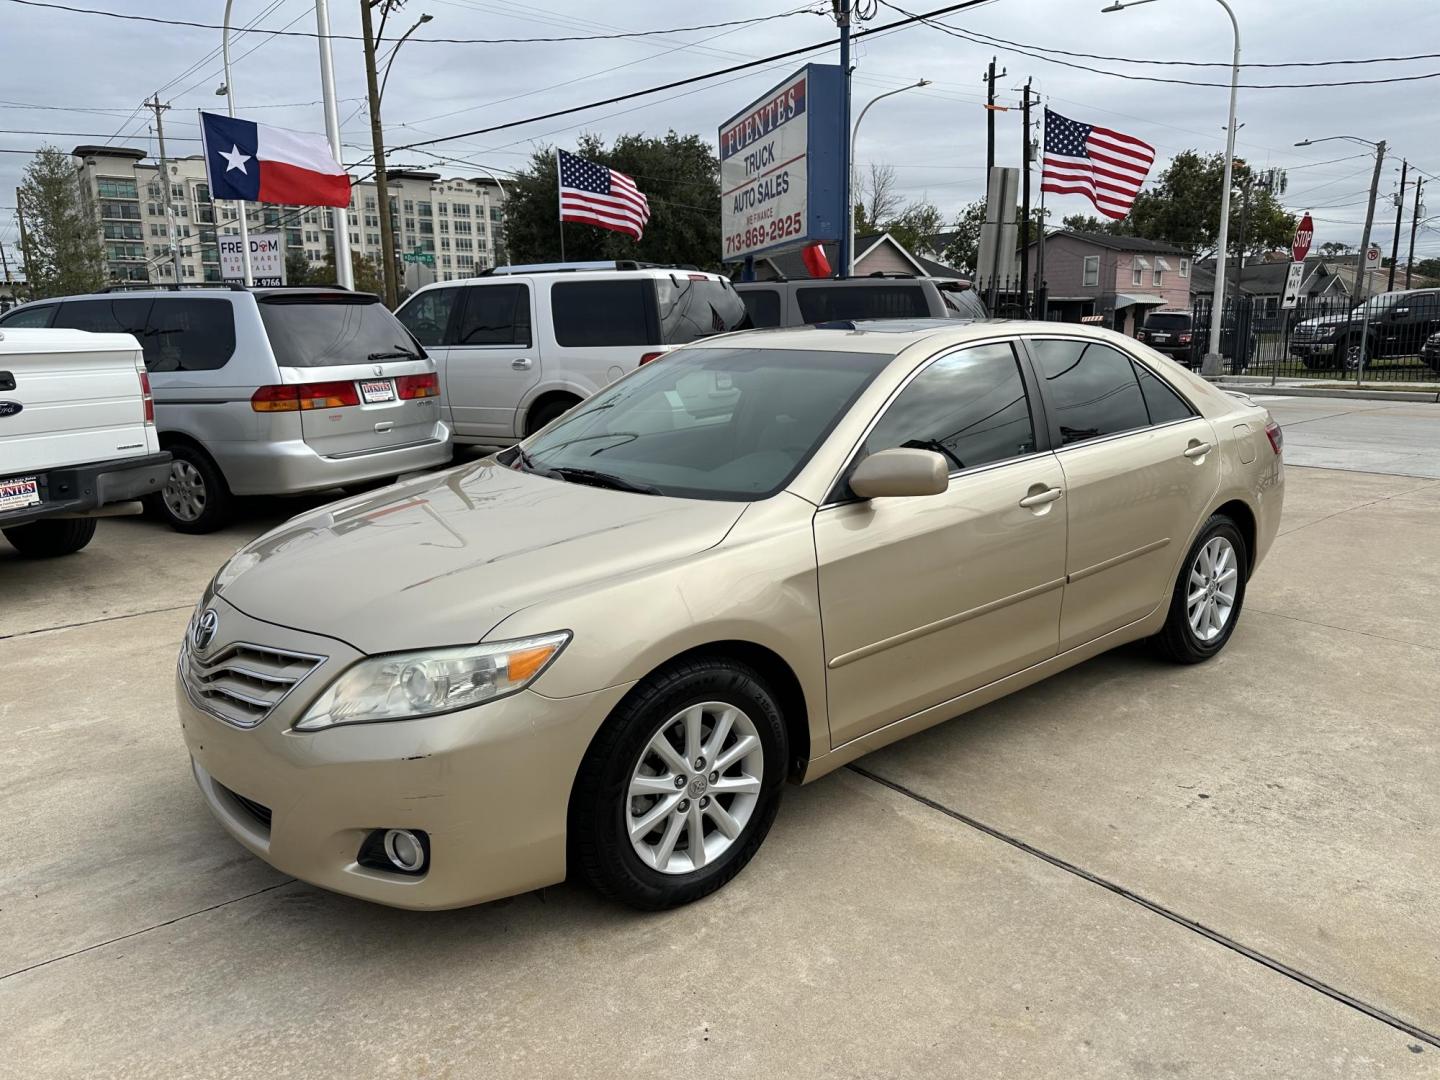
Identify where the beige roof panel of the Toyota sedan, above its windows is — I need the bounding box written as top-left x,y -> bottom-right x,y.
702,318 -> 1135,356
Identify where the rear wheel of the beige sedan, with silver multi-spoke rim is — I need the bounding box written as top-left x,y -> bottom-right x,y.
1153,514 -> 1250,664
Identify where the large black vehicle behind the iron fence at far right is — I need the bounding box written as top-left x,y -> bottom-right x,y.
1290,289 -> 1440,370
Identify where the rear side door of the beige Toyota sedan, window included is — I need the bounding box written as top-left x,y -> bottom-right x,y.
1028,338 -> 1220,651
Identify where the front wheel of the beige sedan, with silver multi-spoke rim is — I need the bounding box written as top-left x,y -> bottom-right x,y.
569,658 -> 788,910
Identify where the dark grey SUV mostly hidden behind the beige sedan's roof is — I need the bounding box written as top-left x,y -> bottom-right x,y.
734,274 -> 989,327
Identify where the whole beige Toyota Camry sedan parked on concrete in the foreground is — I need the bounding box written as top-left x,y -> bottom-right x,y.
177,323 -> 1283,909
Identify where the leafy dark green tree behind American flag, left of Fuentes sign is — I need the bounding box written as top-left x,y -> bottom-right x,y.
505,131 -> 720,269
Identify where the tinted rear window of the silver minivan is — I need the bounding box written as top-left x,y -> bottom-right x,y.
259,294 -> 423,367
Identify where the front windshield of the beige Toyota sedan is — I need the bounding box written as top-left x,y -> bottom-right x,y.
501,347 -> 891,501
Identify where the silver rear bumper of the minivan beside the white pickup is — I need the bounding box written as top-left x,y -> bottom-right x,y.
207,420 -> 454,495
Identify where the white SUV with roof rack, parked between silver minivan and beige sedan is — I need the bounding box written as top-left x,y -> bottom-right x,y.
396,262 -> 744,444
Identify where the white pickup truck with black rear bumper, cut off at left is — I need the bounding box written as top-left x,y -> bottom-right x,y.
0,328 -> 170,557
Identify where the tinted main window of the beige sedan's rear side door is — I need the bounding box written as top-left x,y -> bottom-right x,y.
1030,338 -> 1151,446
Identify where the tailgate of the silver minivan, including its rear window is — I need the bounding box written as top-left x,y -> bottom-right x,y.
256,292 -> 439,456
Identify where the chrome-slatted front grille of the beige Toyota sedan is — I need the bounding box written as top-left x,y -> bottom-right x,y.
180,636 -> 325,727
